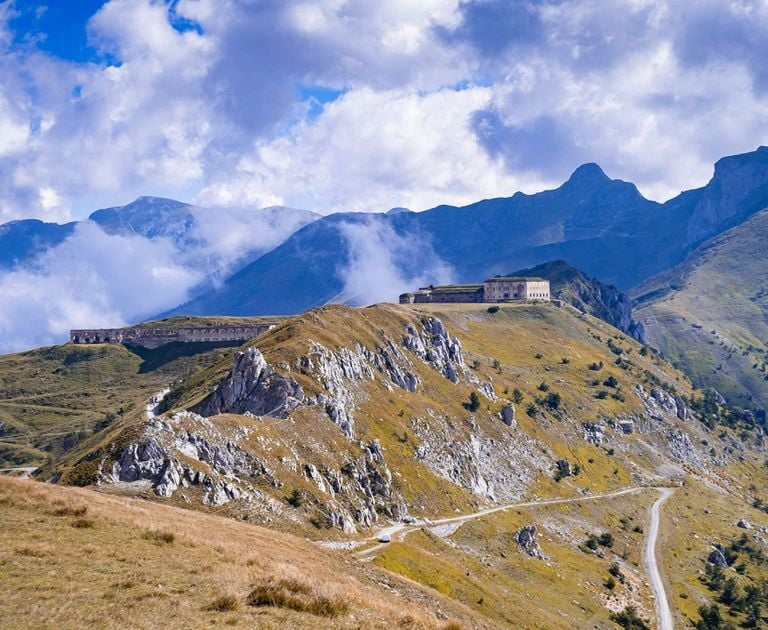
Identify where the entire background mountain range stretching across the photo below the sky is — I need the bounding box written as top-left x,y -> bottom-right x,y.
0,146 -> 768,406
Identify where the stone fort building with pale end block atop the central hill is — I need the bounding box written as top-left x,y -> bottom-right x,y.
400,276 -> 550,304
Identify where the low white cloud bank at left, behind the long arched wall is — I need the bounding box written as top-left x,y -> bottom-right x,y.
0,223 -> 202,352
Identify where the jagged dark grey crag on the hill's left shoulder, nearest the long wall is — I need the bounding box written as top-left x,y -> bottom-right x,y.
190,348 -> 305,418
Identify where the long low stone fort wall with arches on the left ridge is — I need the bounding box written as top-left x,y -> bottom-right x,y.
69,322 -> 276,349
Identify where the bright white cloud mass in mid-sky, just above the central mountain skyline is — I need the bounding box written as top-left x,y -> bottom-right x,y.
195,87 -> 548,211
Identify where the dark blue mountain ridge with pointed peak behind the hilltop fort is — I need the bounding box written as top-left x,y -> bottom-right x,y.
173,147 -> 768,315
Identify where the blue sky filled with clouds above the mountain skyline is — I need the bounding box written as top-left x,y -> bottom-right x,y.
0,0 -> 768,222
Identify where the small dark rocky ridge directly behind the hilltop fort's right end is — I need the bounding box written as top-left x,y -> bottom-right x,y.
508,260 -> 645,342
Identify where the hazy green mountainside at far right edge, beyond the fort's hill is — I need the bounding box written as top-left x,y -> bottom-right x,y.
633,210 -> 768,408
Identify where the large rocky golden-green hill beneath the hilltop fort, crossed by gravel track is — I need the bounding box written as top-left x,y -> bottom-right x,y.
42,304 -> 768,628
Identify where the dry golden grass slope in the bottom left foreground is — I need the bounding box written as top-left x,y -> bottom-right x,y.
0,477 -> 484,628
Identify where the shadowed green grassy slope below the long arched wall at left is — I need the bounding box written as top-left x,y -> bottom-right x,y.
0,343 -> 240,467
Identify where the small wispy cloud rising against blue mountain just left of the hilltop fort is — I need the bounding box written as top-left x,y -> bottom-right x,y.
336,217 -> 455,304
